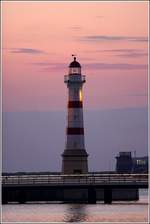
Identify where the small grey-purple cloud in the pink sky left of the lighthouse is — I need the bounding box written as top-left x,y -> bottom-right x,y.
10,48 -> 46,54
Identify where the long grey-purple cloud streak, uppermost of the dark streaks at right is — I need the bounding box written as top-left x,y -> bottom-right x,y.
79,35 -> 148,42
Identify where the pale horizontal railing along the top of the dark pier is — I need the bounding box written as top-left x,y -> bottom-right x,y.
2,174 -> 148,186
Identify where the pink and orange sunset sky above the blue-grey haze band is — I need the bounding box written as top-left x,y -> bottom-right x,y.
2,1 -> 148,111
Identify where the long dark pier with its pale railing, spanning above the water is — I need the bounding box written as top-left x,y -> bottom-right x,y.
2,174 -> 148,204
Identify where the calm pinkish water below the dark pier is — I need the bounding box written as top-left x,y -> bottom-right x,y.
2,190 -> 148,224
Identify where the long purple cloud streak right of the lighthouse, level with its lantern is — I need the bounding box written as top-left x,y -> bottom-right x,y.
85,63 -> 148,70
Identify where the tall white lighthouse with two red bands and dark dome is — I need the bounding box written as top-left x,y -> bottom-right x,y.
62,57 -> 88,174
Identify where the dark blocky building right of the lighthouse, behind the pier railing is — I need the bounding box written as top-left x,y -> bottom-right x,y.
116,152 -> 148,173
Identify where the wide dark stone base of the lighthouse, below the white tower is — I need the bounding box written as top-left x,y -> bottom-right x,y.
62,149 -> 88,174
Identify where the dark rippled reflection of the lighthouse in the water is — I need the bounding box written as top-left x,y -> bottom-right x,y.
64,204 -> 87,222
